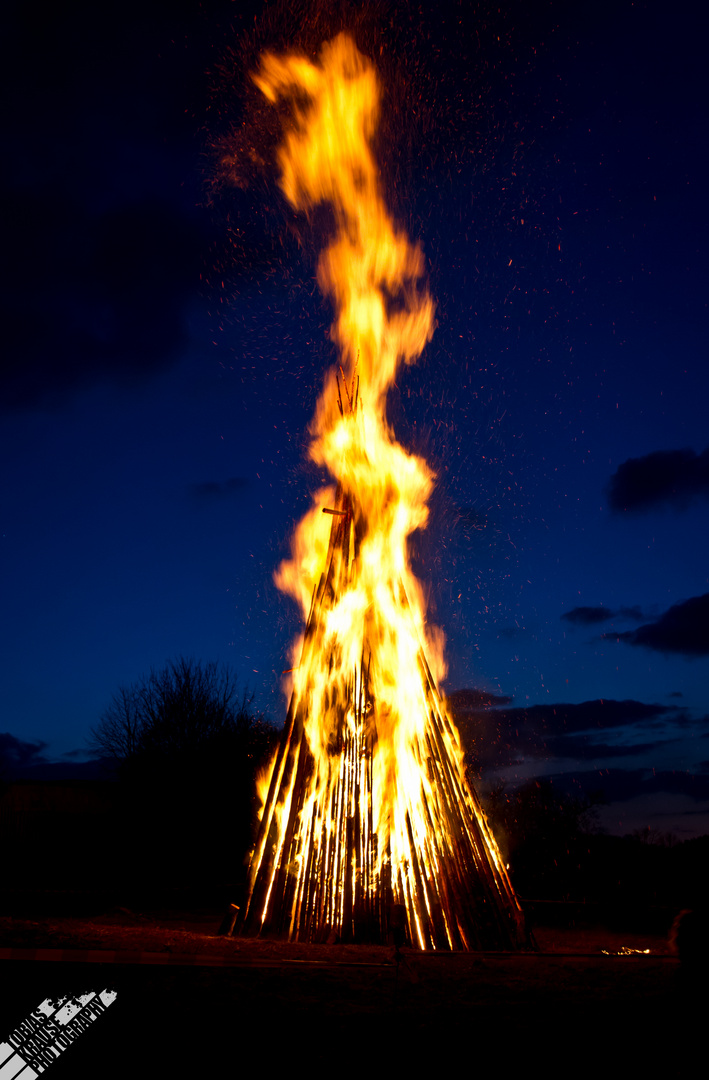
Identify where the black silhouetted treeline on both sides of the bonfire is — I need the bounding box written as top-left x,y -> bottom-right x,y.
0,658 -> 709,928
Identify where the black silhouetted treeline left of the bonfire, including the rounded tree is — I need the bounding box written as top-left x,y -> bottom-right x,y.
0,658 -> 278,908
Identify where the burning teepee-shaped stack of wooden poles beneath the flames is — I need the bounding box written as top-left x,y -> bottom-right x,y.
237,479 -> 525,949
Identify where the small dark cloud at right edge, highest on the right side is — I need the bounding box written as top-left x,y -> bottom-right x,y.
607,447 -> 709,512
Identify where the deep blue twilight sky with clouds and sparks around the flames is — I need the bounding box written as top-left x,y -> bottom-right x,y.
0,0 -> 709,837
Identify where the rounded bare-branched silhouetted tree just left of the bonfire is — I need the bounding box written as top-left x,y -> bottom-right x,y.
91,658 -> 277,885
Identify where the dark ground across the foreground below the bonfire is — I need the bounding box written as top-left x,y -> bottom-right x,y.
0,910 -> 706,1080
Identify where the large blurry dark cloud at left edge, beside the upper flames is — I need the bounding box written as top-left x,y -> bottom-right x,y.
0,190 -> 200,410
